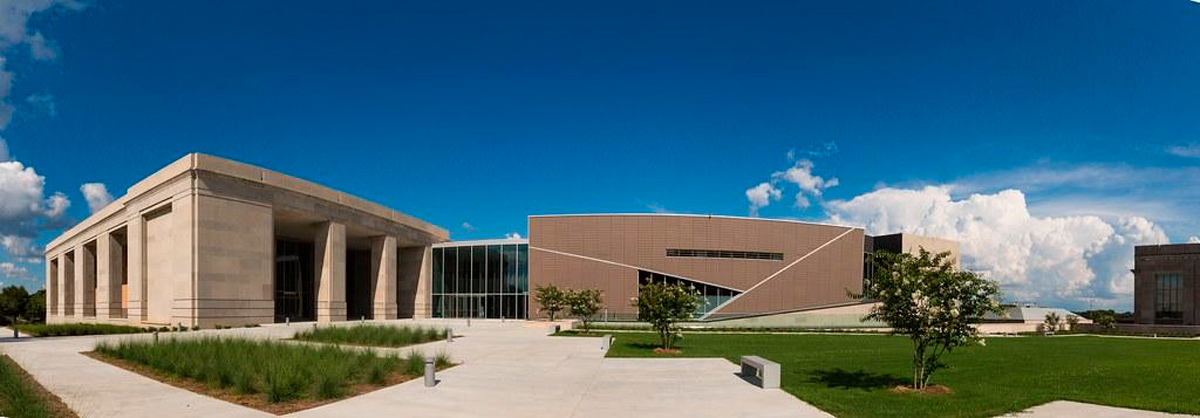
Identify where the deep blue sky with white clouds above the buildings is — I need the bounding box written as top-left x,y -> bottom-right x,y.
0,0 -> 1200,309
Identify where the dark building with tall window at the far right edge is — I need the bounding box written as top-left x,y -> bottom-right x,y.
1133,244 -> 1200,326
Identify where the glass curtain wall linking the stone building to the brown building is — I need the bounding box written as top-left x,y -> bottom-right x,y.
432,244 -> 529,320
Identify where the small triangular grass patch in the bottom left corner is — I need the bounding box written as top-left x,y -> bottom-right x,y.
0,356 -> 78,418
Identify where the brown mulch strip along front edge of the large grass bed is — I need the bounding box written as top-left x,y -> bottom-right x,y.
83,352 -> 416,417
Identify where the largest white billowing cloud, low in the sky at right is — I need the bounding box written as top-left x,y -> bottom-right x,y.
826,186 -> 1168,307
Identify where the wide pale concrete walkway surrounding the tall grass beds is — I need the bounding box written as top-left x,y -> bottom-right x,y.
0,320 -> 829,418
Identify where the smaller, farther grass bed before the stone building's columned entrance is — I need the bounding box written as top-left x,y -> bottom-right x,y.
295,324 -> 446,347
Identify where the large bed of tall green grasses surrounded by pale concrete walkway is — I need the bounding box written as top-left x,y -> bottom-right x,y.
91,336 -> 450,414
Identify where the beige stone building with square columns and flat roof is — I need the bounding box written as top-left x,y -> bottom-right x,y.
46,154 -> 449,328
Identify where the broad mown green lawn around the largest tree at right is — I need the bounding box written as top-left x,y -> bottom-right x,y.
608,333 -> 1200,417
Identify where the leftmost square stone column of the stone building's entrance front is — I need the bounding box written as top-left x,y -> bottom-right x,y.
313,222 -> 346,322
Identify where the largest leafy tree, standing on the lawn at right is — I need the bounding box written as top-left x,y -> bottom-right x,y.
863,249 -> 1003,390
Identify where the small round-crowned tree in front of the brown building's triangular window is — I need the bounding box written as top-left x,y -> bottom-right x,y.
634,283 -> 700,350
